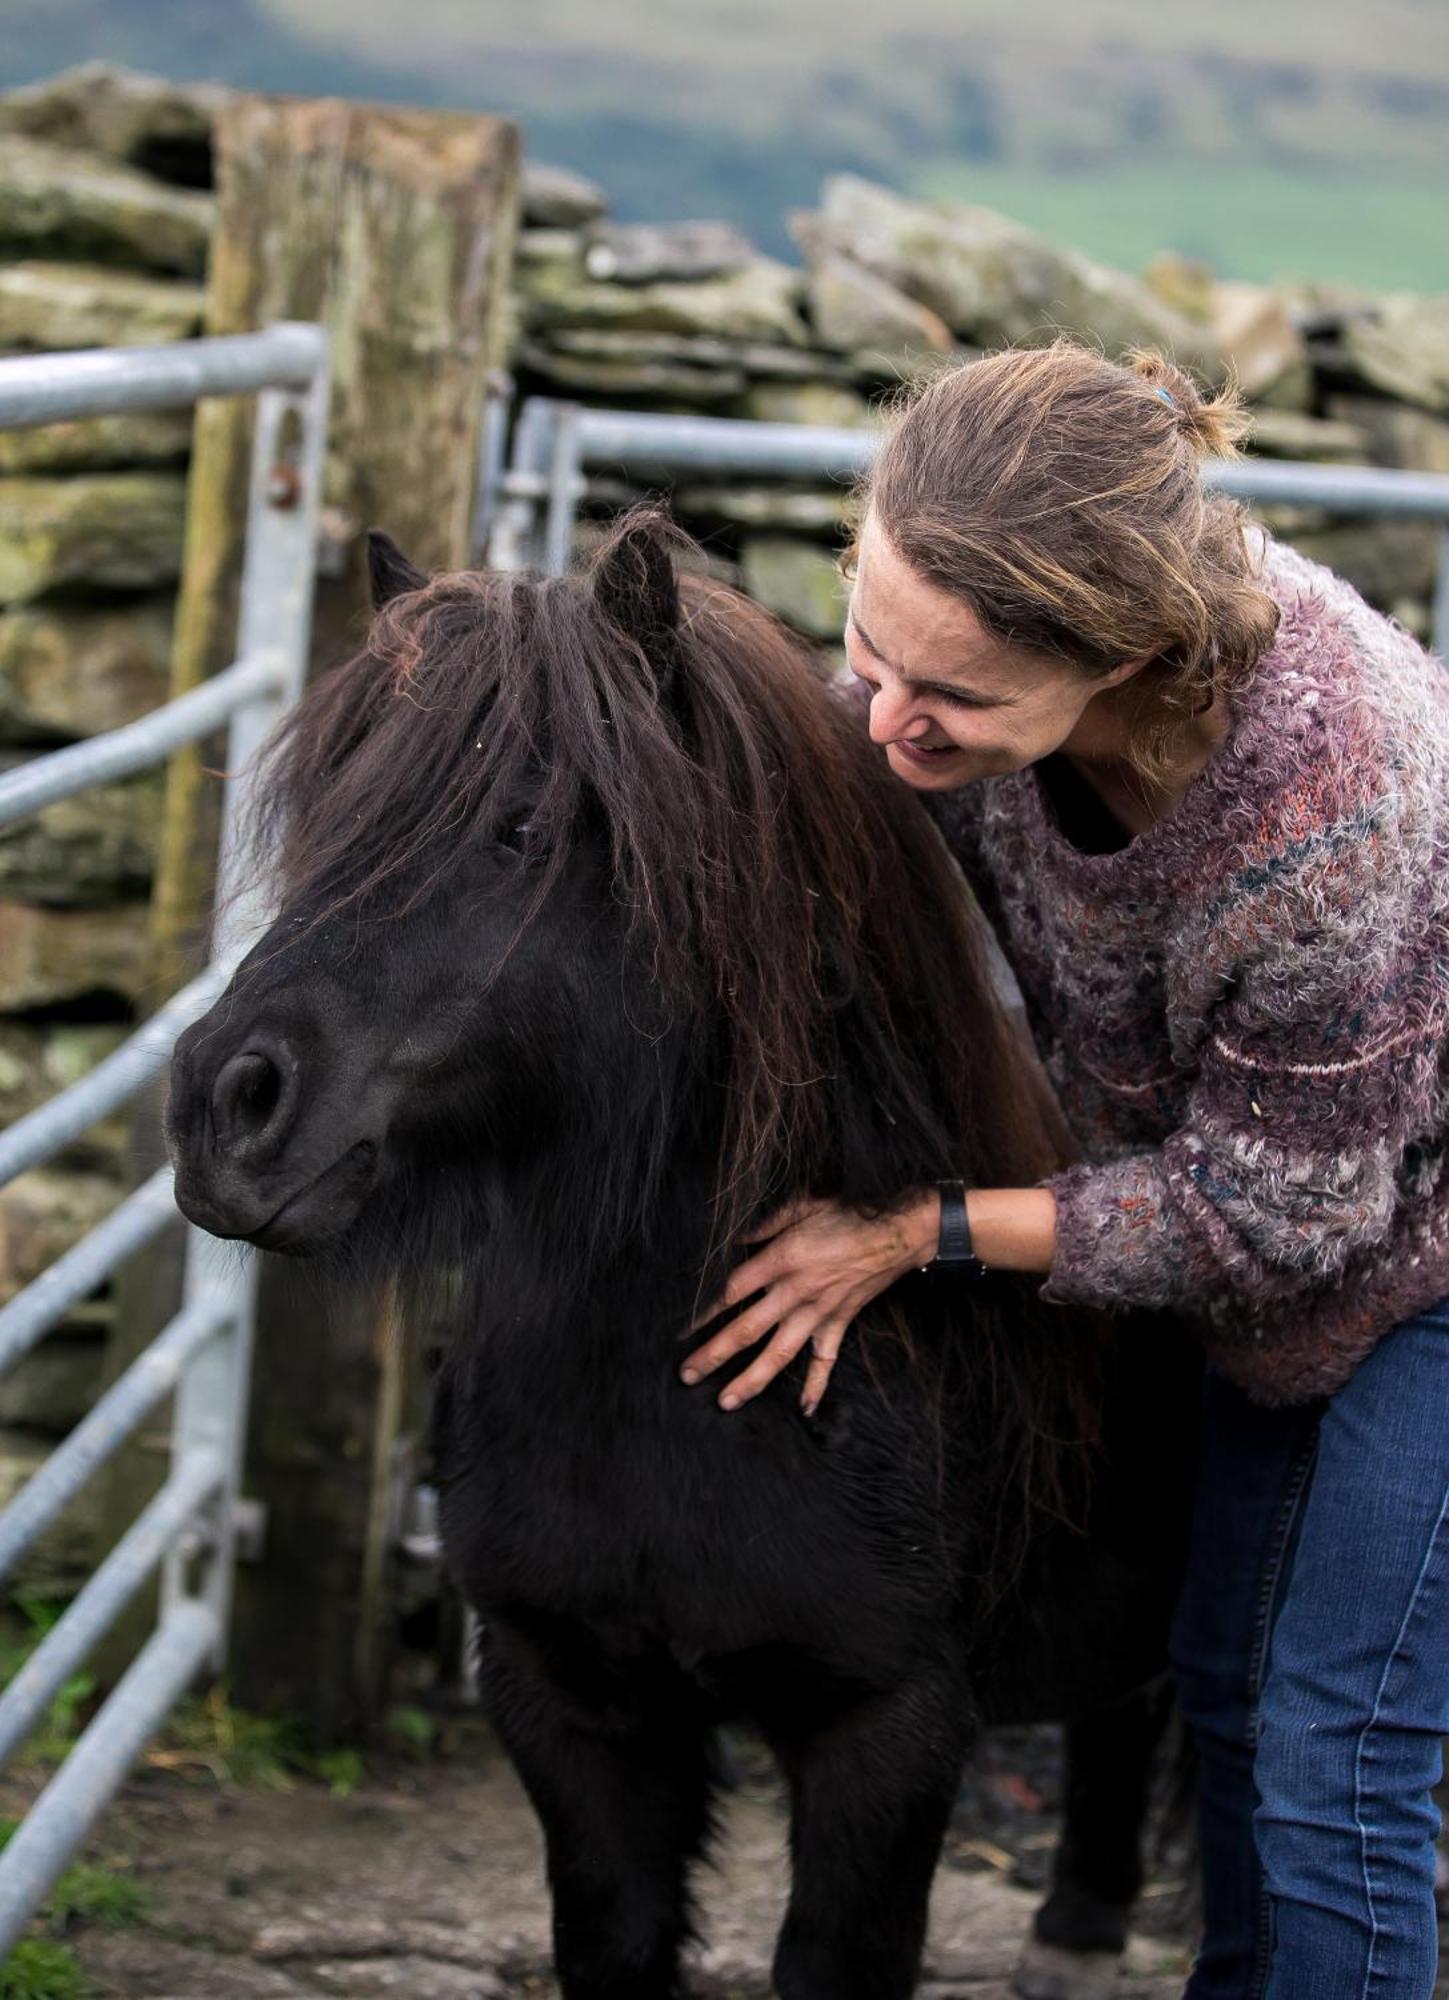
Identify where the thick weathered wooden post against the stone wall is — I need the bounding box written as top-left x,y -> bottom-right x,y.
104,96 -> 518,1736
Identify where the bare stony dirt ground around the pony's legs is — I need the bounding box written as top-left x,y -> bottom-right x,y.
4,1750 -> 1185,2000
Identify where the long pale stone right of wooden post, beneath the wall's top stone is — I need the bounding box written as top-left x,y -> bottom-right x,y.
518,258 -> 809,346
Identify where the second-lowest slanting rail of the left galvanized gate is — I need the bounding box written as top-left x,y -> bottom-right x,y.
0,1452 -> 226,1764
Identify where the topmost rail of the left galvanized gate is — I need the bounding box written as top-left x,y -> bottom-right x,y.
0,320 -> 326,430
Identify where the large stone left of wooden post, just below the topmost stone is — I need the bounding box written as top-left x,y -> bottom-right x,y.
0,134 -> 216,278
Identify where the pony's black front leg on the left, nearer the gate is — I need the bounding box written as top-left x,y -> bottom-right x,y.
480,1620 -> 710,2000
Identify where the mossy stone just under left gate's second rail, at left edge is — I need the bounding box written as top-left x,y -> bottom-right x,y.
0,752 -> 164,908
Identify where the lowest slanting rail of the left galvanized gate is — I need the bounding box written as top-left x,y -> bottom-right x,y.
0,1604 -> 216,1958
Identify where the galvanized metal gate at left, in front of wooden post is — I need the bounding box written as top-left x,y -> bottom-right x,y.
0,324 -> 328,1956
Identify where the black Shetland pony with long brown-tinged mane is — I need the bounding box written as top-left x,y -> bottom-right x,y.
170,514 -> 1191,2000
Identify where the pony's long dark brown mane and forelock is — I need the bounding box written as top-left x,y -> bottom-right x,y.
260,516 -> 1081,1528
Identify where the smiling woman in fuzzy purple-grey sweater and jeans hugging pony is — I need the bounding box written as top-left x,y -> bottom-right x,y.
684,342 -> 1449,2000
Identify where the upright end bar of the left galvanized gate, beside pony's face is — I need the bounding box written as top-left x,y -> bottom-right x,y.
162,344 -> 328,1672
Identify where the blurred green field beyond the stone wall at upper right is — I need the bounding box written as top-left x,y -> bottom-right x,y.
913,162 -> 1449,292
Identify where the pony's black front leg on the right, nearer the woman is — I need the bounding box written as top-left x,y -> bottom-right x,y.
773,1672 -> 971,2000
